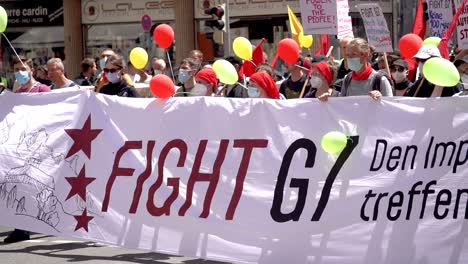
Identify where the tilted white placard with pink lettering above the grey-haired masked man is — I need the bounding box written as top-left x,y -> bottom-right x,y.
357,4 -> 393,52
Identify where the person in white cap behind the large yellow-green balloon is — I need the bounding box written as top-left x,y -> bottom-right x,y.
405,45 -> 463,97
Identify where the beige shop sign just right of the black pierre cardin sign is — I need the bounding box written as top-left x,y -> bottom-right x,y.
81,0 -> 175,24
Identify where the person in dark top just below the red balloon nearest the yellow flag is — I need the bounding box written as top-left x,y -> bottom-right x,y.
280,56 -> 311,99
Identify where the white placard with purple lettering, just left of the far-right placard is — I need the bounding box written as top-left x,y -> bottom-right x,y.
427,0 -> 453,38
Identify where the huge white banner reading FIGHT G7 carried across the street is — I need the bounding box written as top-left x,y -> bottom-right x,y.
0,91 -> 468,264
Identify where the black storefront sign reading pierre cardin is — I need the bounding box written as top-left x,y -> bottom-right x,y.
0,0 -> 63,28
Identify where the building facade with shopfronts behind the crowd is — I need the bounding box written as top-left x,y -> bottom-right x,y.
0,0 -> 416,80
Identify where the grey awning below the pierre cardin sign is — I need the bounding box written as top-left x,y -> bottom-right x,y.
11,27 -> 64,49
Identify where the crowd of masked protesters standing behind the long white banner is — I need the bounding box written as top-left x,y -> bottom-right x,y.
0,37 -> 468,105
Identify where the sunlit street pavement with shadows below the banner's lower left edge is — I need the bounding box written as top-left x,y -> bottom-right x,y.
0,227 -> 225,264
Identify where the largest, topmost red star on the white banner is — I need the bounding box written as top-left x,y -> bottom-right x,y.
65,114 -> 102,159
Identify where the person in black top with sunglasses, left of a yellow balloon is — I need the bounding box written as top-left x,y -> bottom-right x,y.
100,55 -> 138,97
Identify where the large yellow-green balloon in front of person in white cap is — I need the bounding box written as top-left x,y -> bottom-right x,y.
423,58 -> 460,87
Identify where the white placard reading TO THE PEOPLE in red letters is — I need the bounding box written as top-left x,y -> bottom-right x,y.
300,0 -> 338,35
